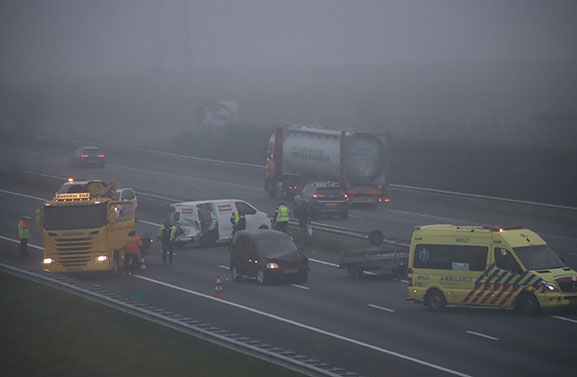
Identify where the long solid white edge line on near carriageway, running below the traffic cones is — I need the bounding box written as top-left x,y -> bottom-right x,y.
133,275 -> 471,377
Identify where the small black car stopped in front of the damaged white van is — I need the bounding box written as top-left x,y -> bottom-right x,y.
229,229 -> 309,285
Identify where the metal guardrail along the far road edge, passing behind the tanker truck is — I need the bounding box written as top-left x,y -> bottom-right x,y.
12,133 -> 577,211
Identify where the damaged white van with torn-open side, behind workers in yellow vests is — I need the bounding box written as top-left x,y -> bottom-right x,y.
168,199 -> 271,247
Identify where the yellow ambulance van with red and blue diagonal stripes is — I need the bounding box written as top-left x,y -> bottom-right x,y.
408,224 -> 577,314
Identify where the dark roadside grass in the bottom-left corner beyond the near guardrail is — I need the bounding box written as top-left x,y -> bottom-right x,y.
0,273 -> 301,377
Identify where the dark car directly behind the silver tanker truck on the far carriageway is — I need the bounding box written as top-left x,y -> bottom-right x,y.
293,182 -> 349,219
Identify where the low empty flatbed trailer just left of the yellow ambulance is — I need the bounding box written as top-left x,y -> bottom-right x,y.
339,245 -> 409,279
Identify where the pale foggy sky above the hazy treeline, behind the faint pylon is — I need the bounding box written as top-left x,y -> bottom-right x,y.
0,0 -> 577,80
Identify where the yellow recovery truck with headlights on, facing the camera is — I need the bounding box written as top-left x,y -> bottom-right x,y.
36,181 -> 136,275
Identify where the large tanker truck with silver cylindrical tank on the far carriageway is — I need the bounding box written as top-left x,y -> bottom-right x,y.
265,126 -> 389,206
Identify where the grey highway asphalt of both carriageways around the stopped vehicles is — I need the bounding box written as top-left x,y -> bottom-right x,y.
0,136 -> 577,376
